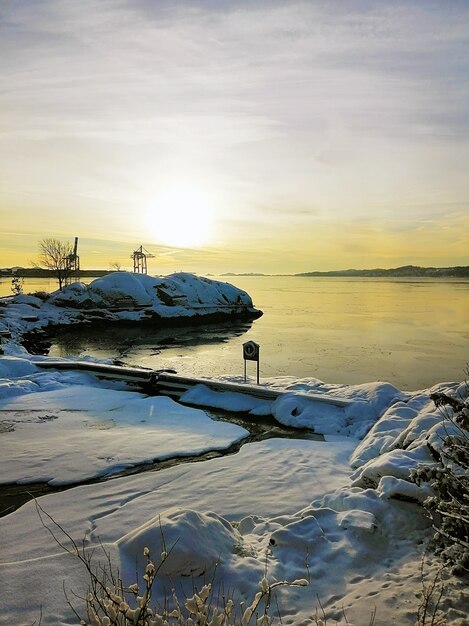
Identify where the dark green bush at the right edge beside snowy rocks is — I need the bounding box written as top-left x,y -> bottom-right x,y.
414,382 -> 469,574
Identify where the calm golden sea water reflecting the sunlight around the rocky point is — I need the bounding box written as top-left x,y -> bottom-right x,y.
3,276 -> 469,389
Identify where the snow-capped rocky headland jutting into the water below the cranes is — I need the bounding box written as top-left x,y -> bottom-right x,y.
0,272 -> 262,354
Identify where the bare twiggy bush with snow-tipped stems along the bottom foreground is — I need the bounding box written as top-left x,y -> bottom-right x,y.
35,501 -> 380,626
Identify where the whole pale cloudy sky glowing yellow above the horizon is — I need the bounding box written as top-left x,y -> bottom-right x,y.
0,0 -> 469,274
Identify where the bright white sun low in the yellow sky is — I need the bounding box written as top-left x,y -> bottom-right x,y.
149,186 -> 214,248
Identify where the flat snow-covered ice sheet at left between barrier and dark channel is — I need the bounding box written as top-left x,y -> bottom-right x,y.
0,373 -> 249,485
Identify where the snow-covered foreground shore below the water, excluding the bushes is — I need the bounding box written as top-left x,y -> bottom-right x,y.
0,357 -> 467,626
